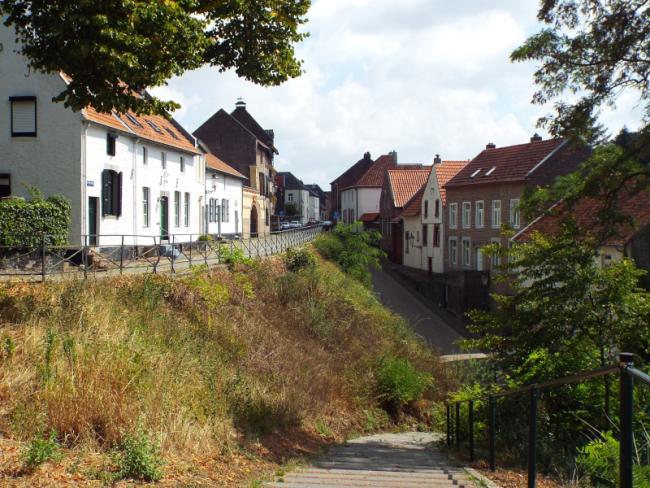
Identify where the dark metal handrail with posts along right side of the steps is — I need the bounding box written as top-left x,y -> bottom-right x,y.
446,353 -> 650,488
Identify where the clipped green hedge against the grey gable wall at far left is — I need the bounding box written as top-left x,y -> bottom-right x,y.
0,191 -> 71,247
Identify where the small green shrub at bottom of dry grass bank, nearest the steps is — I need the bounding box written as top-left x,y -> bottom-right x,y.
115,429 -> 163,481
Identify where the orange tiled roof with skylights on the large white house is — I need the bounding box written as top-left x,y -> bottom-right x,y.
60,73 -> 201,154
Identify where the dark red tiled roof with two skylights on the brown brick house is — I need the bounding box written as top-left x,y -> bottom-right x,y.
447,139 -> 566,188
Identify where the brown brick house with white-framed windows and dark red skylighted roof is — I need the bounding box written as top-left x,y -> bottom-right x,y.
444,134 -> 590,272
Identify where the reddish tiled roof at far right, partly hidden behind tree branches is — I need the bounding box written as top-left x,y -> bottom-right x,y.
513,190 -> 650,246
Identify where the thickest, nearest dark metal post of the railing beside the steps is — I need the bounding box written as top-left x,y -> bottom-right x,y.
618,352 -> 634,488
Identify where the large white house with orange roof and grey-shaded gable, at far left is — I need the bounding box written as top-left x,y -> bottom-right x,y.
0,27 -> 205,245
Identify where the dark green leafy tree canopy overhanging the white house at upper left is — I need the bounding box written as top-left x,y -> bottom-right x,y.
0,0 -> 310,114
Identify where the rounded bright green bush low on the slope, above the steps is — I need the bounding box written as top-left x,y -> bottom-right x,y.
377,358 -> 432,409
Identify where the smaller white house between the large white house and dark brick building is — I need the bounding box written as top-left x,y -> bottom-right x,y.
205,153 -> 246,236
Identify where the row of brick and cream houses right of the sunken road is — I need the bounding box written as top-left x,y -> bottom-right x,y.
331,134 -> 650,315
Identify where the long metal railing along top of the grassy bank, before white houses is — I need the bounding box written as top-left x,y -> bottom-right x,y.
0,225 -> 323,281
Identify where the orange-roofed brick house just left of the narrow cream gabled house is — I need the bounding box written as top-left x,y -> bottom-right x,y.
379,166 -> 431,264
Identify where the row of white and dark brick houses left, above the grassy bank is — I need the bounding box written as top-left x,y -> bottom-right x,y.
0,27 -> 325,245
